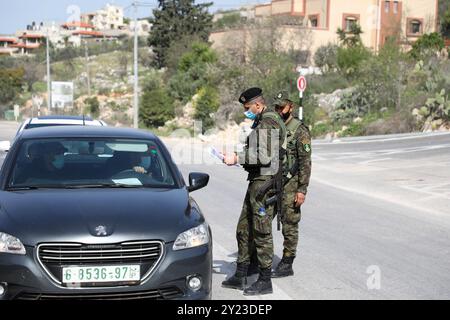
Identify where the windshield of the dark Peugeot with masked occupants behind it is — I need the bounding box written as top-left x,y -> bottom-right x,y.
7,139 -> 175,189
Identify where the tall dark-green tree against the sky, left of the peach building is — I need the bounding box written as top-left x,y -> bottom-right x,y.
148,0 -> 212,68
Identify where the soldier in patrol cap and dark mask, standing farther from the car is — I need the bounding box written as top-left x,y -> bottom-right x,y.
272,92 -> 311,278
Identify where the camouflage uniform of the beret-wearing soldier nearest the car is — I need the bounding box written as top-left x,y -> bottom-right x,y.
236,111 -> 286,269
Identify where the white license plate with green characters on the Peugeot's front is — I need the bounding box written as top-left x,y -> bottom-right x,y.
62,265 -> 141,283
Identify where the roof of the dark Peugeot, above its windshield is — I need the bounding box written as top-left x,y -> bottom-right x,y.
19,126 -> 158,140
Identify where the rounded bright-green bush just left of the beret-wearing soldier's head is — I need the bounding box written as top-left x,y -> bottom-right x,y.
194,87 -> 220,131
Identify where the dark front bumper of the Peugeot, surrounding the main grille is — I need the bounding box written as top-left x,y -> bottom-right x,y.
0,243 -> 212,300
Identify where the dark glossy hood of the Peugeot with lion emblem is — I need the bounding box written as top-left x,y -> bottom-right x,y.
0,189 -> 204,246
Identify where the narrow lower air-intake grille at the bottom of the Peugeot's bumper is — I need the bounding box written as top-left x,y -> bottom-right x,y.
15,287 -> 183,300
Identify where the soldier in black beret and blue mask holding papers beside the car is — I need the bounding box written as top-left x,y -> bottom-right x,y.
222,88 -> 286,295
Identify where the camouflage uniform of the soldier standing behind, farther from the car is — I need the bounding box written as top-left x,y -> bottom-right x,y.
282,118 -> 311,258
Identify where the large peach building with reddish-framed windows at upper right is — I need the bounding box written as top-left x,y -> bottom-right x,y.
210,0 -> 438,63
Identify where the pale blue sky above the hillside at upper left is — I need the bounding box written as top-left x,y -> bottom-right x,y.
0,0 -> 270,34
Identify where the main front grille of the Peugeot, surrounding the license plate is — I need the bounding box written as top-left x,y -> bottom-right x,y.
38,241 -> 163,287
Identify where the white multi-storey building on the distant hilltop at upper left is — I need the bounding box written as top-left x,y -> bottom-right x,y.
81,4 -> 125,31
